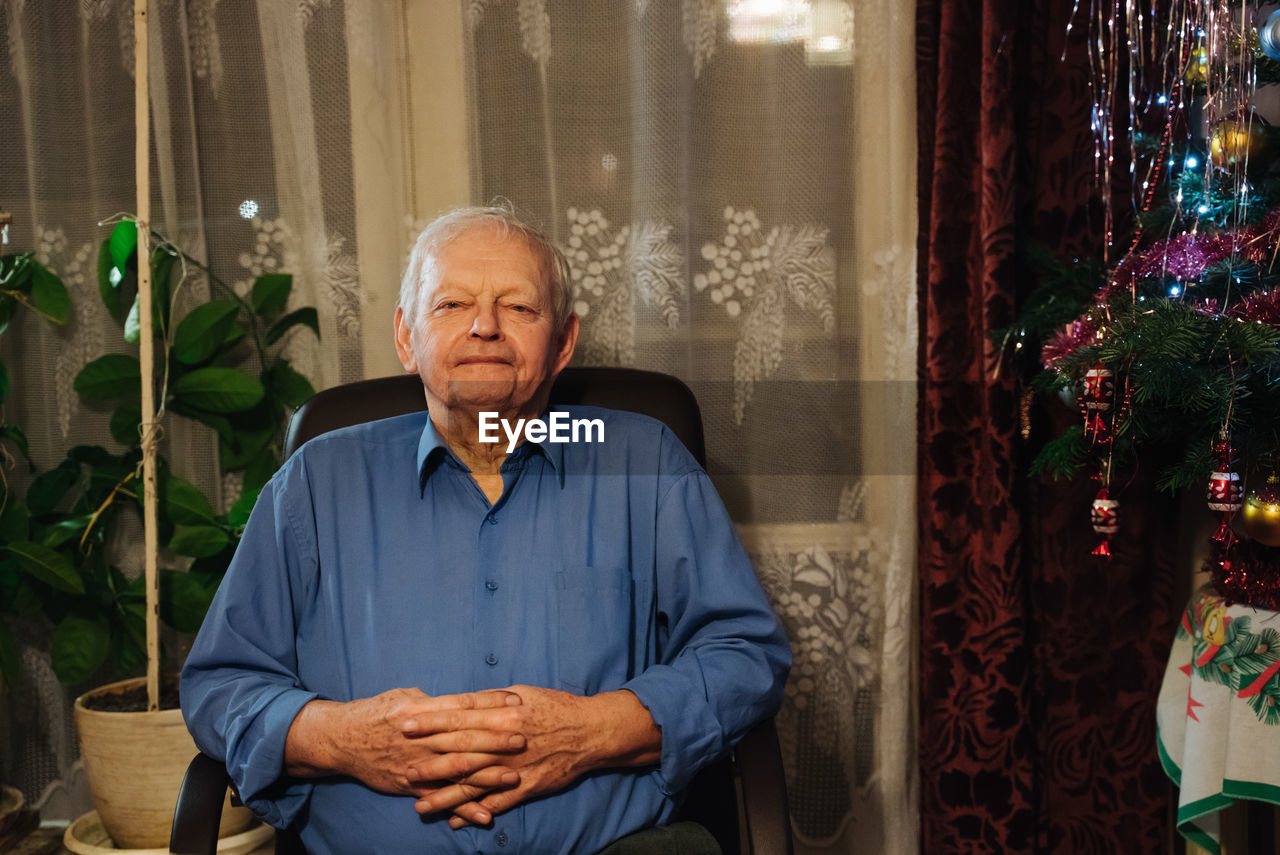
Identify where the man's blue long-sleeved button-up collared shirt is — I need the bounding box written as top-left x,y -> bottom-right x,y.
182,407 -> 791,855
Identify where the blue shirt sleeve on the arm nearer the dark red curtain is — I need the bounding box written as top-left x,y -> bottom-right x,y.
623,470 -> 791,795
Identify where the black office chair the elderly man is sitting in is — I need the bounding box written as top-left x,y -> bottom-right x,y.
169,367 -> 791,855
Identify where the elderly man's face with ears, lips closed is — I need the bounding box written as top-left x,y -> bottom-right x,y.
396,225 -> 577,419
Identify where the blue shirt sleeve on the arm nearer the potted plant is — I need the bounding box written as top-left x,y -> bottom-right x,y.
182,461 -> 317,828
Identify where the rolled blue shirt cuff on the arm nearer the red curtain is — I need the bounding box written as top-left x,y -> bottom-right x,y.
622,651 -> 727,796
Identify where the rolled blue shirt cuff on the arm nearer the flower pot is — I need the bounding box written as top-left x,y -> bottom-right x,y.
227,689 -> 319,828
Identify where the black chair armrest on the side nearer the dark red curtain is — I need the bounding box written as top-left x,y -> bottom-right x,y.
733,718 -> 792,855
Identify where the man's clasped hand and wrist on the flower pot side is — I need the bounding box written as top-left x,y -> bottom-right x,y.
284,689 -> 525,824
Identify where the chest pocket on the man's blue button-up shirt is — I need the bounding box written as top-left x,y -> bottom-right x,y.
556,564 -> 634,695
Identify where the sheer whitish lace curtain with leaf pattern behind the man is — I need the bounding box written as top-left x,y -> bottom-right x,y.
0,0 -> 918,852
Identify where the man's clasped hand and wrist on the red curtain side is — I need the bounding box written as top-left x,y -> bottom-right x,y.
415,686 -> 662,828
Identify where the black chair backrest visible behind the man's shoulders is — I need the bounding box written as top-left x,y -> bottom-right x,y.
284,367 -> 707,466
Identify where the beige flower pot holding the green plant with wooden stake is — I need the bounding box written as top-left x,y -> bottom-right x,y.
76,677 -> 253,849
